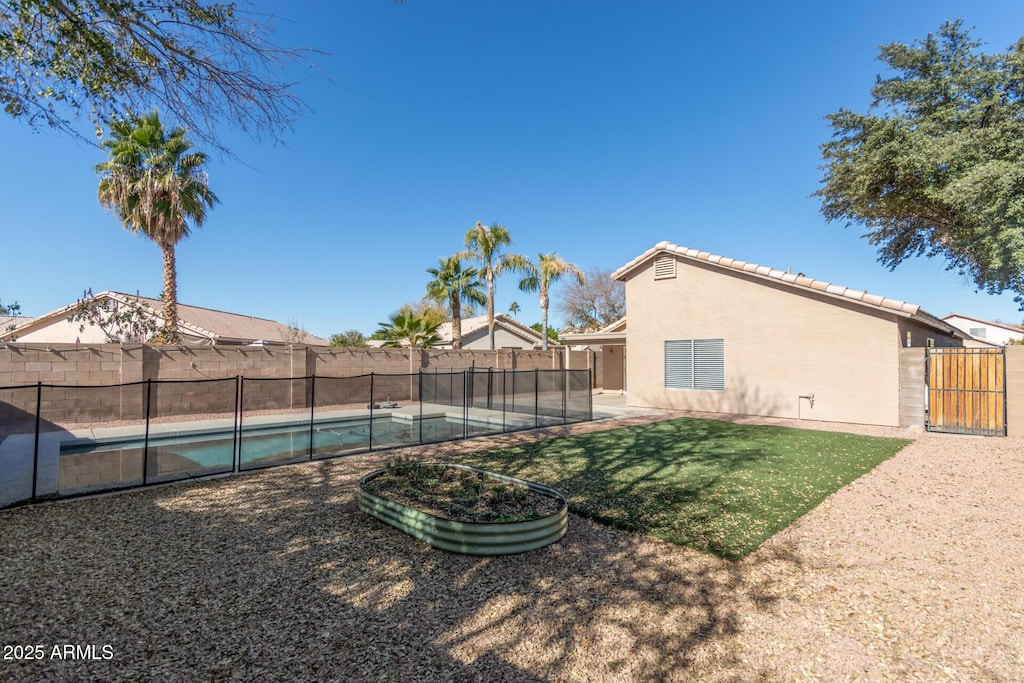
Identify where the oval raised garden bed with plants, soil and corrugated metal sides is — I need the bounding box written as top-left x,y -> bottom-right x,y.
358,461 -> 568,555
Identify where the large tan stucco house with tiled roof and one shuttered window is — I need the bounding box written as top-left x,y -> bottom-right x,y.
612,242 -> 968,426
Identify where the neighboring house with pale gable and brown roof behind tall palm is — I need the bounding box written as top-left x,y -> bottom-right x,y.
0,292 -> 328,346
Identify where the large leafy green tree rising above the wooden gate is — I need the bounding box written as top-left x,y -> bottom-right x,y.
816,22 -> 1024,306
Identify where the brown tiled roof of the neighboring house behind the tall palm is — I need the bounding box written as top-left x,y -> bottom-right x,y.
0,292 -> 329,346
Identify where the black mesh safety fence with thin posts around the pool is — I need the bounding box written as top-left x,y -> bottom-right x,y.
0,369 -> 593,508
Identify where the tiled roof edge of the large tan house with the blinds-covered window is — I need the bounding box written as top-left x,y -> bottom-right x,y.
611,242 -> 970,339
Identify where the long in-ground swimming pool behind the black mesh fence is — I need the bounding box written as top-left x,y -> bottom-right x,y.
59,415 -> 501,481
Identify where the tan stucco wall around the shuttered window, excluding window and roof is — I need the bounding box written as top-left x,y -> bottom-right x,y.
626,259 -> 958,426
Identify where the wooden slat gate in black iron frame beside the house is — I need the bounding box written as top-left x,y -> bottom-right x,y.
926,348 -> 1007,436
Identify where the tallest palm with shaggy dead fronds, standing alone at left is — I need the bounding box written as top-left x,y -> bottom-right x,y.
96,111 -> 218,343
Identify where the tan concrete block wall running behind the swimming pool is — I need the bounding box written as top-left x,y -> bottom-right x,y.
0,343 -> 577,426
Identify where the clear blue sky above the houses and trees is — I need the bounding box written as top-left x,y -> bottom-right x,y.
0,0 -> 1024,336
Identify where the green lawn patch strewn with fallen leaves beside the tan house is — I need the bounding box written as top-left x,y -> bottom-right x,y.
458,418 -> 910,560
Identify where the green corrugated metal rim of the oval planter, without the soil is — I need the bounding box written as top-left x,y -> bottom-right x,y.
358,463 -> 568,555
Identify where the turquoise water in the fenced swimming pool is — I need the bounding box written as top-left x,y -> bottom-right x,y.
60,417 -> 494,474
